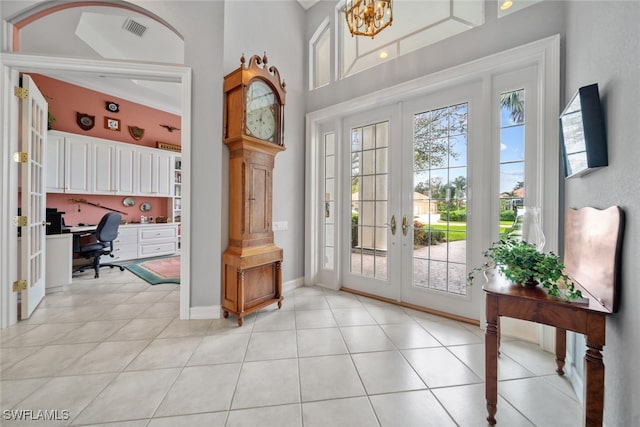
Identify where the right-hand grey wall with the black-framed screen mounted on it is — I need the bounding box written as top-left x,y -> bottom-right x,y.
563,1 -> 640,427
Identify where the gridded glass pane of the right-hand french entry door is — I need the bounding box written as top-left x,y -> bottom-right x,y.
413,103 -> 468,295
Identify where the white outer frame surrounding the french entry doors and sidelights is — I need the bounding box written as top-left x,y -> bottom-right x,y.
305,35 -> 560,320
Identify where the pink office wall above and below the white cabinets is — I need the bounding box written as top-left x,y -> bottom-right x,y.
30,74 -> 181,225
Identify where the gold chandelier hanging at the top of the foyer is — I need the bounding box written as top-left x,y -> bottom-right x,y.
344,0 -> 393,38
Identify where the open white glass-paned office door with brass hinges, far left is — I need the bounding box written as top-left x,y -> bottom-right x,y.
20,75 -> 47,319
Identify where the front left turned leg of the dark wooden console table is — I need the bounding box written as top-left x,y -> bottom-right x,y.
484,295 -> 498,425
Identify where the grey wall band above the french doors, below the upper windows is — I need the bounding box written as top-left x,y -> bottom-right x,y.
306,0 -> 564,111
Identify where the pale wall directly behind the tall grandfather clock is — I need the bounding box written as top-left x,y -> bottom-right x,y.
222,0 -> 307,283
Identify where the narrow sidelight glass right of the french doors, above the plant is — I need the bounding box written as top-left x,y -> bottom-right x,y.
498,89 -> 525,238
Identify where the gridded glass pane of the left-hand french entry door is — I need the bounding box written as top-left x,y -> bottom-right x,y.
350,122 -> 389,279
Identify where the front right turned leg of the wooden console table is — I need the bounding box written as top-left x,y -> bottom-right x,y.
584,336 -> 604,427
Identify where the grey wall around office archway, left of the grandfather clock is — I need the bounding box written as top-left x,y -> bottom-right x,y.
0,0 -> 226,307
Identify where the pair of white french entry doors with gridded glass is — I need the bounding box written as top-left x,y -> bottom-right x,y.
342,85 -> 482,318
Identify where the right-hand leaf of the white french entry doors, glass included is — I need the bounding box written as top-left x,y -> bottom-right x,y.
401,84 -> 484,319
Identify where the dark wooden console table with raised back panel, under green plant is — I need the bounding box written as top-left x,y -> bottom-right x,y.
484,206 -> 624,427
